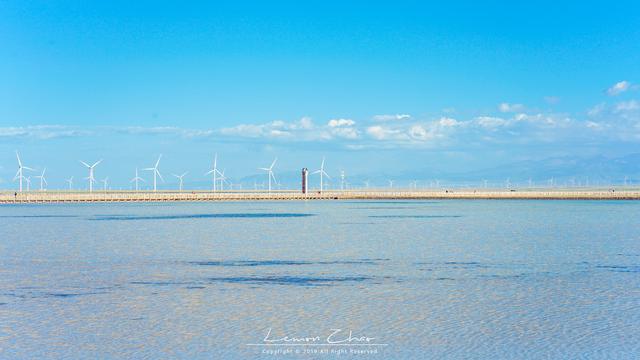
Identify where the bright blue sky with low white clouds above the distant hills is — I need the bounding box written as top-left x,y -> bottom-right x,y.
0,1 -> 640,187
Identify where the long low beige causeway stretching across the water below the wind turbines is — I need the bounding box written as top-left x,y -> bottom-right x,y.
0,189 -> 640,204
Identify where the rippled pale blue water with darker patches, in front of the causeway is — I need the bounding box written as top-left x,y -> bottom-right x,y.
0,200 -> 640,359
